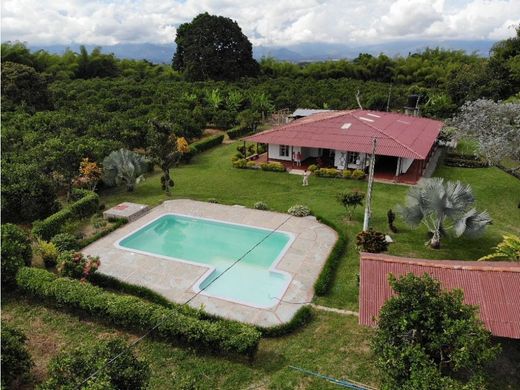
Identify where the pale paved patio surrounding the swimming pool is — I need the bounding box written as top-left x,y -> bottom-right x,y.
83,199 -> 337,326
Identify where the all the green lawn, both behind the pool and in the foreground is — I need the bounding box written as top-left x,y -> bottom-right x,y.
2,145 -> 520,389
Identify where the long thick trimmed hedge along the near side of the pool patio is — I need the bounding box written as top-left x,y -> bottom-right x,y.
16,267 -> 261,357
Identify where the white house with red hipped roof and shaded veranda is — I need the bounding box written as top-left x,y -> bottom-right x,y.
244,110 -> 443,183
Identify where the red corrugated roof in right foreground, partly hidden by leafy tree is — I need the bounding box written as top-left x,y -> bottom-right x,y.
359,253 -> 520,339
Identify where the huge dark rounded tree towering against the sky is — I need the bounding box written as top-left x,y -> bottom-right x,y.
172,12 -> 259,80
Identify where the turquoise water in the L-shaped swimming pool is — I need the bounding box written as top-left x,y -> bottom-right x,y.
119,214 -> 291,307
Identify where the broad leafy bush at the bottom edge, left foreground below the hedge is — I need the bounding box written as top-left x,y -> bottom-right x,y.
41,338 -> 151,390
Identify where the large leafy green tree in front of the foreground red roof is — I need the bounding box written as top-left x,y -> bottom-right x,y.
373,274 -> 498,390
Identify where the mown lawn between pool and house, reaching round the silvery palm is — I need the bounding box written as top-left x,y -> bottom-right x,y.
101,143 -> 520,310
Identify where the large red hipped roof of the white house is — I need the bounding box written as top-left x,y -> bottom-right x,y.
244,110 -> 443,160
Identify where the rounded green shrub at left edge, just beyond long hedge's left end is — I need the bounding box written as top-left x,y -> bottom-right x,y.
1,223 -> 32,286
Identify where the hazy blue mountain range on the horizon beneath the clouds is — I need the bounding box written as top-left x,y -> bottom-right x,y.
29,40 -> 494,64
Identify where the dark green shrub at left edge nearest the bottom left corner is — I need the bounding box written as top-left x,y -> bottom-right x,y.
2,321 -> 33,388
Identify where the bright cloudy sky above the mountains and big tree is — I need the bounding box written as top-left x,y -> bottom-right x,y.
1,0 -> 520,46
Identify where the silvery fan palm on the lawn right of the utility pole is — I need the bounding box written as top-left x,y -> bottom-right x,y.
398,177 -> 491,249
